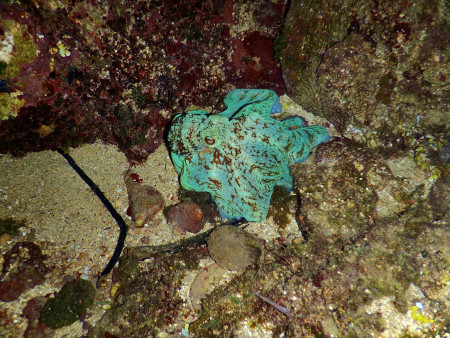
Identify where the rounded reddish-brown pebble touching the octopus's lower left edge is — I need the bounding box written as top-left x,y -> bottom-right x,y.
167,201 -> 205,233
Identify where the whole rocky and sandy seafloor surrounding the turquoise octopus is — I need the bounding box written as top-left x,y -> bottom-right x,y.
0,0 -> 450,337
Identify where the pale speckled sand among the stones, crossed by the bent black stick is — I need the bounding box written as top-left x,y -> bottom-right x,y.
0,96 -> 314,337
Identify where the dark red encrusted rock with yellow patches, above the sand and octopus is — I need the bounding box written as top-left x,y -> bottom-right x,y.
0,0 -> 286,163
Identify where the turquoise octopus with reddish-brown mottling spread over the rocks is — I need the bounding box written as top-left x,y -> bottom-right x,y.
168,89 -> 330,222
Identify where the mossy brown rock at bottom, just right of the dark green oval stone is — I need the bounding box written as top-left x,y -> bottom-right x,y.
88,246 -> 206,337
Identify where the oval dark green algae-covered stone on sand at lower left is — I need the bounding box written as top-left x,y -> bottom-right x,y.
40,279 -> 95,329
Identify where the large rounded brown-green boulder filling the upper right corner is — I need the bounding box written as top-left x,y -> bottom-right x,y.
281,0 -> 449,151
